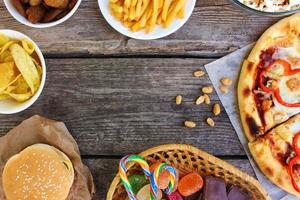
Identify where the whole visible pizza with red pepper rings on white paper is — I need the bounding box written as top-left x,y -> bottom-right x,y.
237,14 -> 300,196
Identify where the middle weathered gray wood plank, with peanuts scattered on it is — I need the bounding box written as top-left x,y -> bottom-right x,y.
0,58 -> 245,155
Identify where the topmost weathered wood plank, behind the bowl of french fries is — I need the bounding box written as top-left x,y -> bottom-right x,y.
0,0 -> 277,57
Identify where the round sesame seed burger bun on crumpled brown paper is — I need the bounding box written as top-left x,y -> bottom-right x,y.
2,144 -> 74,200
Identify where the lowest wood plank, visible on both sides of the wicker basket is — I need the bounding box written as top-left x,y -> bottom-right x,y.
84,159 -> 255,200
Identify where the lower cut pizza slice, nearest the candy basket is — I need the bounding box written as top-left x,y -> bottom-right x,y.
249,114 -> 300,196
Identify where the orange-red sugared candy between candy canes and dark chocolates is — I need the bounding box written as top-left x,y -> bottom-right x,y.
178,172 -> 203,197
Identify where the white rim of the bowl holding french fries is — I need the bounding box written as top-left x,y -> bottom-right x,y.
98,0 -> 196,40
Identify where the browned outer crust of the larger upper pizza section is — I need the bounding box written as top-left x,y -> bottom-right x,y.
238,13 -> 300,141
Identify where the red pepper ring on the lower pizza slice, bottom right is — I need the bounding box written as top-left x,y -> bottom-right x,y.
288,156 -> 300,192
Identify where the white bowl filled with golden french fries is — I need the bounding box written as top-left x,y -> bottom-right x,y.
98,0 -> 196,40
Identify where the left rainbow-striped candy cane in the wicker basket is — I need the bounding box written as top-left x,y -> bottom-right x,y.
119,155 -> 151,200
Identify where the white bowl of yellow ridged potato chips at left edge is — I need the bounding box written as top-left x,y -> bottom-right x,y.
0,30 -> 46,114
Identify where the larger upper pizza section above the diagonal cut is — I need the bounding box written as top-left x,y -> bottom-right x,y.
238,14 -> 300,141
